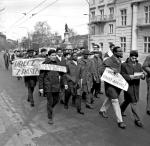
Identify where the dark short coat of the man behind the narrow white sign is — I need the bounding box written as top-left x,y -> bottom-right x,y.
39,58 -> 66,93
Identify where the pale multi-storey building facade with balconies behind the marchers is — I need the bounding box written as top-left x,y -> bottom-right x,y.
89,0 -> 150,58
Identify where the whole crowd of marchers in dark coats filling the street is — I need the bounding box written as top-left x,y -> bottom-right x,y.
4,44 -> 150,129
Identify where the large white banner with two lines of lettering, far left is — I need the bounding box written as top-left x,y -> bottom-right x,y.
12,58 -> 45,76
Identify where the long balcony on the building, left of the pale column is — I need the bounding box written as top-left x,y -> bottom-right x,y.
91,15 -> 115,23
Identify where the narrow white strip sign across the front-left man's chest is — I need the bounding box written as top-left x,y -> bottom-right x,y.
40,64 -> 67,73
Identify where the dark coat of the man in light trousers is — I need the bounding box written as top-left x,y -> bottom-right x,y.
102,55 -> 121,99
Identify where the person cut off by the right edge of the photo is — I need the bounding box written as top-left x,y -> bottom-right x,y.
142,55 -> 150,116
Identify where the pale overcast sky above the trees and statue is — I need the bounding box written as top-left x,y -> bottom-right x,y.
0,0 -> 88,39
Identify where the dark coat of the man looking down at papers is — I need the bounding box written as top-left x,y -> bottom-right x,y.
121,59 -> 143,103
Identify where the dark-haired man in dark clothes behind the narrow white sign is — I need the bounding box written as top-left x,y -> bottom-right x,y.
39,50 -> 67,124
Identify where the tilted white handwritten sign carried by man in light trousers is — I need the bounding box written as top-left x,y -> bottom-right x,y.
101,68 -> 129,91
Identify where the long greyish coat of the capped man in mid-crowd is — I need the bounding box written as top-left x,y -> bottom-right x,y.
79,58 -> 94,92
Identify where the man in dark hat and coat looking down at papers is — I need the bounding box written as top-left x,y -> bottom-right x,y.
121,51 -> 145,127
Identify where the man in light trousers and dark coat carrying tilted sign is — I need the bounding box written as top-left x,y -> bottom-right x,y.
99,47 -> 126,129
